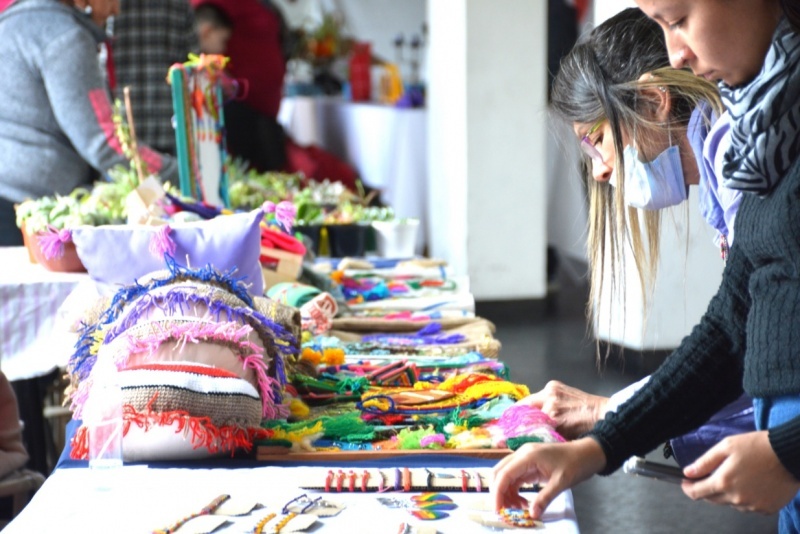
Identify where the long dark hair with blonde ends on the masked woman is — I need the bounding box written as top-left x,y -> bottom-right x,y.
552,9 -> 722,362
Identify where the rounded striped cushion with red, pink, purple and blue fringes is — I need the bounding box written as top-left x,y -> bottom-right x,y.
68,260 -> 297,461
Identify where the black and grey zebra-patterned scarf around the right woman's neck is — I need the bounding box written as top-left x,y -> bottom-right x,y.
720,18 -> 800,194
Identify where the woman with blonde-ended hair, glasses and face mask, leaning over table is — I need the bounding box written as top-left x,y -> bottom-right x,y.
520,9 -> 755,465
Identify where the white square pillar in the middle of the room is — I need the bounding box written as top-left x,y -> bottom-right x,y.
428,0 -> 547,299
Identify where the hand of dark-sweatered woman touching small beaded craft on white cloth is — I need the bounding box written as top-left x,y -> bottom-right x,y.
491,438 -> 606,519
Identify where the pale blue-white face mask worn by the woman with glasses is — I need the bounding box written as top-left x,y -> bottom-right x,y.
609,145 -> 687,210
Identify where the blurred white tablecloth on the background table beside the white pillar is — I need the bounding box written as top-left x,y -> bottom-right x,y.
278,97 -> 428,253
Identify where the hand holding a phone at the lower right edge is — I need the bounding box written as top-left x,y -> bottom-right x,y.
681,430 -> 800,514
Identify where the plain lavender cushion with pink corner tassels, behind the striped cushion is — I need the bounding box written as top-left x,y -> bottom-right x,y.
72,210 -> 264,295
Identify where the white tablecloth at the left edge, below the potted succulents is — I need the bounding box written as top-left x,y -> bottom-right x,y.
0,247 -> 89,381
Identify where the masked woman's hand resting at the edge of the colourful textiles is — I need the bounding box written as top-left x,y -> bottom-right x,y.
517,380 -> 608,439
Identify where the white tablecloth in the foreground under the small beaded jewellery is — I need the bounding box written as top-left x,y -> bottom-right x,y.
3,466 -> 578,534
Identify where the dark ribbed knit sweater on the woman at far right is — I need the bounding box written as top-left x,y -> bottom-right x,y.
588,156 -> 800,479
